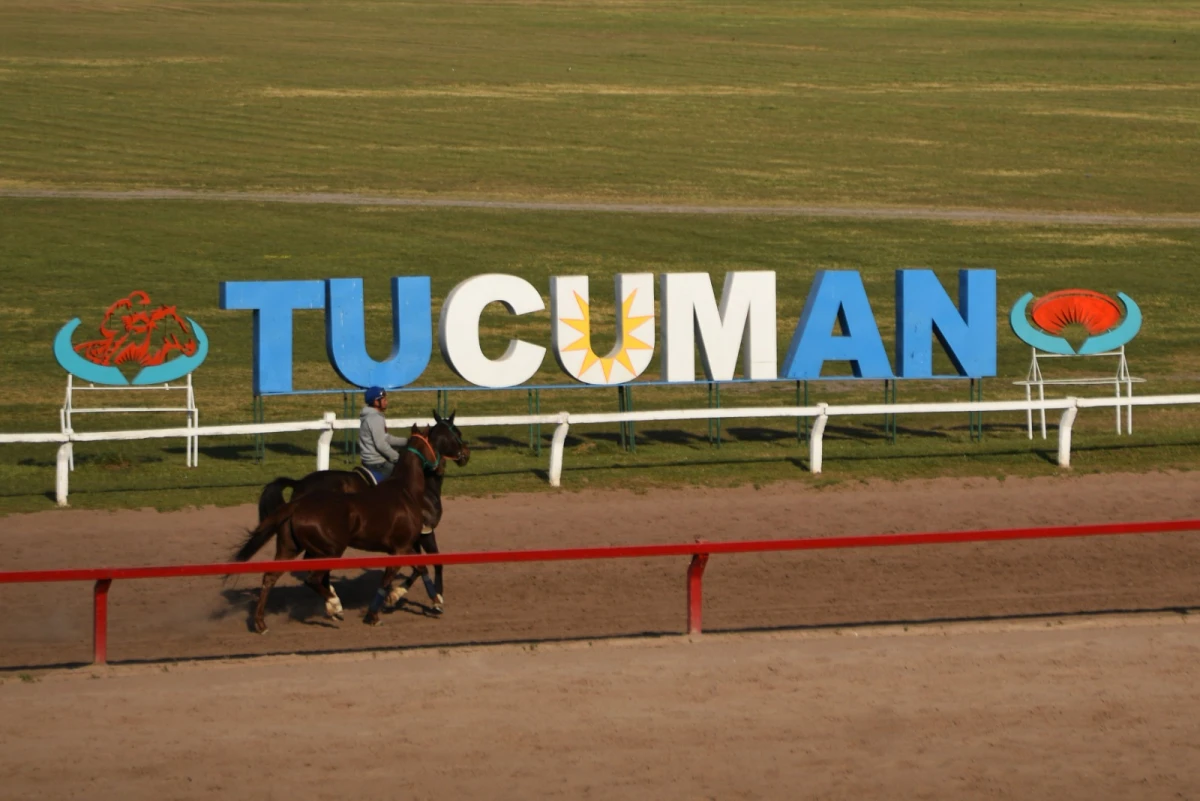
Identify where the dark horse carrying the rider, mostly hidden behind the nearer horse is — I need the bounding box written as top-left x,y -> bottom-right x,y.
258,410 -> 470,615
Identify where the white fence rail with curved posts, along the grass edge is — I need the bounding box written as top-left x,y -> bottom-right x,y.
0,395 -> 1200,506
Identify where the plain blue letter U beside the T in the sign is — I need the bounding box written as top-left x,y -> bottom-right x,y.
325,276 -> 433,389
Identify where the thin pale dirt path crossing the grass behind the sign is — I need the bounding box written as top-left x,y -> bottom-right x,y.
0,188 -> 1200,228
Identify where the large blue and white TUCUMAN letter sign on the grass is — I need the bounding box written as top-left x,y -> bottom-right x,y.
221,270 -> 997,395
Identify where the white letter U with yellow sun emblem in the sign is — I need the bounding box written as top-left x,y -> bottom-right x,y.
551,273 -> 654,384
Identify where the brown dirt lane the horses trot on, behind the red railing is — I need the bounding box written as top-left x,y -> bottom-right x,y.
0,472 -> 1200,669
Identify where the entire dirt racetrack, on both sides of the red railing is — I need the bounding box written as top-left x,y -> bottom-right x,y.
0,472 -> 1200,801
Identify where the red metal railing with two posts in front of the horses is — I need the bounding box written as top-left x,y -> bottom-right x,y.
0,519 -> 1200,664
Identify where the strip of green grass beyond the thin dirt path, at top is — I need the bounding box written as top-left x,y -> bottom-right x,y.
0,0 -> 1200,212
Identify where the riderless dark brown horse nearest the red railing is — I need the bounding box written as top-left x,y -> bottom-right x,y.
234,426 -> 462,634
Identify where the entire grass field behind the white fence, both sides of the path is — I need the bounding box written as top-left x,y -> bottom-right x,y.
0,0 -> 1200,511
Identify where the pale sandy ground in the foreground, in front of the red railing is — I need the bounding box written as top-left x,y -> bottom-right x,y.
0,615 -> 1200,801
